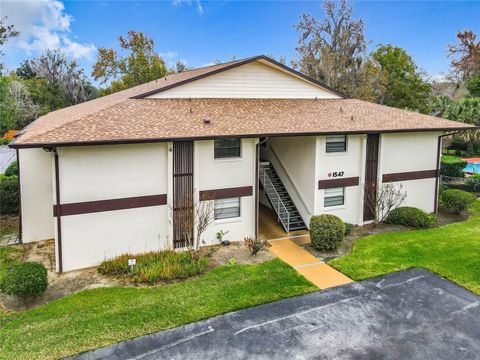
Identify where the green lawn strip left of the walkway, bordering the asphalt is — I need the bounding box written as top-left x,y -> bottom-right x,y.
0,259 -> 318,359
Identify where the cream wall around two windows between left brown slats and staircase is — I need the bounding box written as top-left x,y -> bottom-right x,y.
194,139 -> 258,245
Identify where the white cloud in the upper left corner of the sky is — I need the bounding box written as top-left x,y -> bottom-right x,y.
0,0 -> 96,59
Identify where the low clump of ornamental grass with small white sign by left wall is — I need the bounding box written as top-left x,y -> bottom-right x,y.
98,250 -> 208,284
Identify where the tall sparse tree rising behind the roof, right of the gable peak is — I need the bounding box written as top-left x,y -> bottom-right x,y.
293,0 -> 366,95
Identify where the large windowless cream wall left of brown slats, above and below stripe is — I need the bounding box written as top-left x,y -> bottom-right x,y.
57,143 -> 169,271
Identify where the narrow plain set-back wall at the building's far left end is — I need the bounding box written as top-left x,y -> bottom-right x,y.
19,149 -> 54,243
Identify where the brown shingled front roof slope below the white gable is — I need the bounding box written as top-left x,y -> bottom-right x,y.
14,97 -> 474,147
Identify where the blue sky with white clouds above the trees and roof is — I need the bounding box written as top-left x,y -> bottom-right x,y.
0,0 -> 480,79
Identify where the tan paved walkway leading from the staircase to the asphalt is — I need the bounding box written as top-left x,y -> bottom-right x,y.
270,238 -> 353,289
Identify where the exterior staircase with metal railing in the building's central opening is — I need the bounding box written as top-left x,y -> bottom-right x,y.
259,161 -> 307,233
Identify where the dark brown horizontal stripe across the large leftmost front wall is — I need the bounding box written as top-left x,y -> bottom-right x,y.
53,194 -> 167,216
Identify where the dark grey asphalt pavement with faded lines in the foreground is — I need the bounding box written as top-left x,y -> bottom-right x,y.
73,269 -> 480,360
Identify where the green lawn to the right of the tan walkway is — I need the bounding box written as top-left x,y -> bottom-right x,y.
329,201 -> 480,294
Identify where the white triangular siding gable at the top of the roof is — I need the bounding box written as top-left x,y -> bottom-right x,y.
149,62 -> 339,99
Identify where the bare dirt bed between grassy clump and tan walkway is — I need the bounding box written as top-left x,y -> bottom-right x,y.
201,241 -> 275,265
